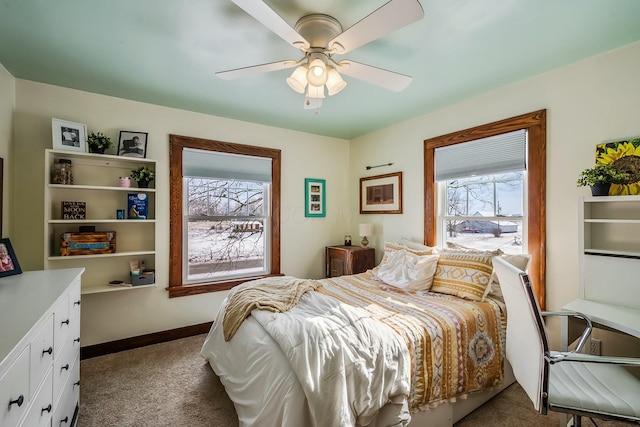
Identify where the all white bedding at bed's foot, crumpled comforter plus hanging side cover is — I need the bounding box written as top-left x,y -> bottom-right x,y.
201,292 -> 411,427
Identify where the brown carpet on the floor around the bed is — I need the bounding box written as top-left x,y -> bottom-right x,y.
78,335 -> 631,427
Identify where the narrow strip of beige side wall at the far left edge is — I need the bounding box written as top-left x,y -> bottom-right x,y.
0,64 -> 16,238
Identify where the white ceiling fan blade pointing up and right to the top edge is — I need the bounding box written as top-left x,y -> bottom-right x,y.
330,0 -> 424,54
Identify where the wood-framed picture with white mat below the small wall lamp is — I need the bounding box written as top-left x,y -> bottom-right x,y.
360,172 -> 402,214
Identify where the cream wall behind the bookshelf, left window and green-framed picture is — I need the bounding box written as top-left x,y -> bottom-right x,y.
14,83 -> 350,346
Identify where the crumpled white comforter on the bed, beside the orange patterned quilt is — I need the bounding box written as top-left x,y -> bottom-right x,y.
252,292 -> 411,426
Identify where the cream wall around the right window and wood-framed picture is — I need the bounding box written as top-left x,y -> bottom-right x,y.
349,39 -> 640,352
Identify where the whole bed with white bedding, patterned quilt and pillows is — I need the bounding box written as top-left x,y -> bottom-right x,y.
201,244 -> 524,427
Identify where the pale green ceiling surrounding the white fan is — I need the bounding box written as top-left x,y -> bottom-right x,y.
0,0 -> 640,139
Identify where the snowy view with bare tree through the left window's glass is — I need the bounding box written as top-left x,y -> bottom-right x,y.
186,178 -> 269,282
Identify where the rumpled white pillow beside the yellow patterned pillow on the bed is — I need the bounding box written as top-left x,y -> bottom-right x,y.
375,249 -> 438,290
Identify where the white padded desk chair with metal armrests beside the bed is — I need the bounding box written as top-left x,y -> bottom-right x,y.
493,257 -> 640,427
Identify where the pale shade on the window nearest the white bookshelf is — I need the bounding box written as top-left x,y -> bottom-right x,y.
182,148 -> 271,182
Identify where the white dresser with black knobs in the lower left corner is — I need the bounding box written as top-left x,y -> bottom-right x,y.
0,268 -> 84,427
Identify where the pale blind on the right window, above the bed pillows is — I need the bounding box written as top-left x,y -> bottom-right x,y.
435,129 -> 527,181
